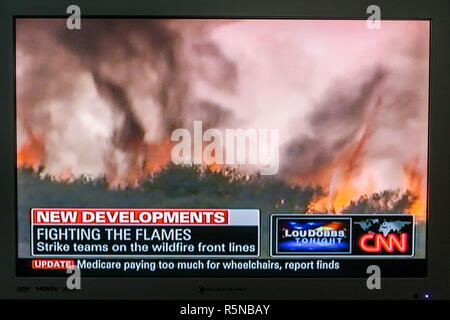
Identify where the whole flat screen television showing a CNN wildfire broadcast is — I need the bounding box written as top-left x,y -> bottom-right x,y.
1,1 -> 449,299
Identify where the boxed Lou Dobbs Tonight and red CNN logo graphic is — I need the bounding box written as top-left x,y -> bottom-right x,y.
271,214 -> 414,257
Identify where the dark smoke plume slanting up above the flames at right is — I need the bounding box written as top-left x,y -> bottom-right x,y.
285,70 -> 384,179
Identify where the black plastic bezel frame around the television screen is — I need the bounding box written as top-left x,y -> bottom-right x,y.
0,0 -> 450,299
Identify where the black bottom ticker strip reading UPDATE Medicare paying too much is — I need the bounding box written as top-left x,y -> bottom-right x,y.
16,257 -> 427,278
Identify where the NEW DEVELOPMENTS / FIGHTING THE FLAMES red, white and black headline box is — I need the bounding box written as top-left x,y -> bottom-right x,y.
31,208 -> 260,257
